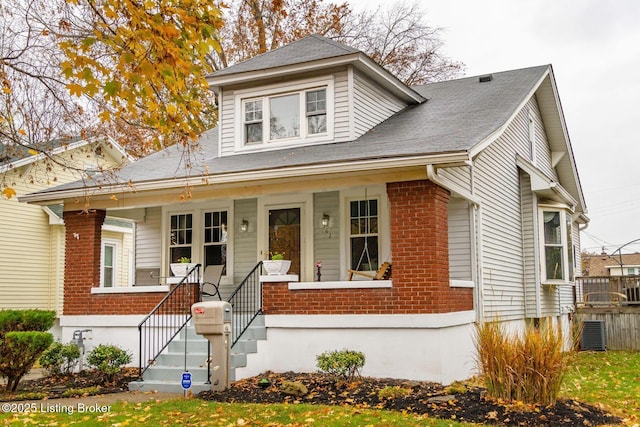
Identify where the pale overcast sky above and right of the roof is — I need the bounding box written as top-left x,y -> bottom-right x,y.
348,0 -> 640,253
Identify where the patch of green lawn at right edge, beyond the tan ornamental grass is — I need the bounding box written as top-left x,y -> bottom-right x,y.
561,351 -> 640,425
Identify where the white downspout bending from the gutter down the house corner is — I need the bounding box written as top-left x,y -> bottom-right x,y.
426,161 -> 484,322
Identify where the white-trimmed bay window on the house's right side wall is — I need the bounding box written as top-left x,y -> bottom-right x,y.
539,207 -> 574,284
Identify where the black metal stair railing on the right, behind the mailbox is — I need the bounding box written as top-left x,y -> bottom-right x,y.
227,261 -> 262,347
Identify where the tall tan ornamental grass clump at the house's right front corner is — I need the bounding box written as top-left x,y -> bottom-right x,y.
476,321 -> 574,405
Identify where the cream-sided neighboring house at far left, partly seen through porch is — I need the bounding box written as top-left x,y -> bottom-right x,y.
0,138 -> 133,320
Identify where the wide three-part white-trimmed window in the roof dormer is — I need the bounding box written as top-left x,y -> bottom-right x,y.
242,87 -> 328,145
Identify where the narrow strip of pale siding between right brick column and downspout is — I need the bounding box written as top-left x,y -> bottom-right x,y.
448,197 -> 473,280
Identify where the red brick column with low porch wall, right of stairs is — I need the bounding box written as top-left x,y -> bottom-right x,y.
263,180 -> 473,314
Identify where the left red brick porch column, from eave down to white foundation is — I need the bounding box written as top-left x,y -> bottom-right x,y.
62,210 -> 106,315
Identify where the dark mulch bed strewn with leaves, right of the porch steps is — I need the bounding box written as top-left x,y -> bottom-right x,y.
198,372 -> 621,426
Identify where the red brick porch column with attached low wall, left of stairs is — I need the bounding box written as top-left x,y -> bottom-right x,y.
62,210 -> 172,315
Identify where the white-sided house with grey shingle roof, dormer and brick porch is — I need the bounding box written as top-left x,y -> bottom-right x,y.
21,36 -> 588,383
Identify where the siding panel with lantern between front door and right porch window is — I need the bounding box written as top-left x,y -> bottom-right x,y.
313,191 -> 340,281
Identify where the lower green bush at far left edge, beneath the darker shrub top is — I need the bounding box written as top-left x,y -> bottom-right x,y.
0,331 -> 53,391
